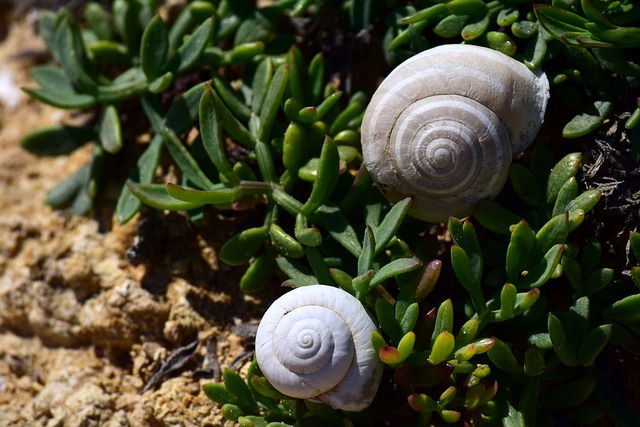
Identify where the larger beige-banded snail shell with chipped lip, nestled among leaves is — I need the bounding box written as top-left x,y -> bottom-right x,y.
362,45 -> 549,222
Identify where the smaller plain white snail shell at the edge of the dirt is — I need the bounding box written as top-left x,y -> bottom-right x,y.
256,285 -> 383,411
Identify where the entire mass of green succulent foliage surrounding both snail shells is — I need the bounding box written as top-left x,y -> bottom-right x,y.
17,0 -> 640,426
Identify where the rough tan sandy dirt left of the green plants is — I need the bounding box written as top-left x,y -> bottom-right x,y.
0,10 -> 277,426
